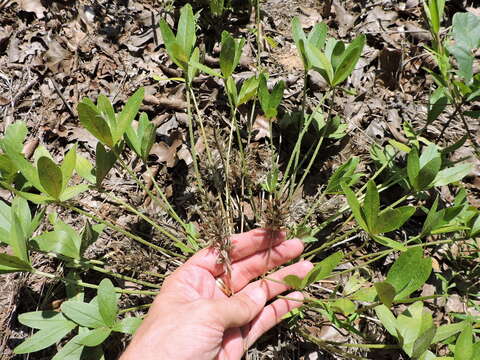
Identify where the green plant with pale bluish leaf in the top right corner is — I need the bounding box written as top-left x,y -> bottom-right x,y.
424,0 -> 480,150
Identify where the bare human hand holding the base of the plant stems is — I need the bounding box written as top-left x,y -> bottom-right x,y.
121,229 -> 313,360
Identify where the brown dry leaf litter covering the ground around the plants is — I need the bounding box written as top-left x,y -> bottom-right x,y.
0,0 -> 480,360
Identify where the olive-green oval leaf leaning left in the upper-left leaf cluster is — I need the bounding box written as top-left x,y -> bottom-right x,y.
77,98 -> 114,147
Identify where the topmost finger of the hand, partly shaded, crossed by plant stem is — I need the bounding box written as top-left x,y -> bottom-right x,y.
185,229 -> 286,276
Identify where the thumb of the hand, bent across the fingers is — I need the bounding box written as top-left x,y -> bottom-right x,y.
215,285 -> 267,329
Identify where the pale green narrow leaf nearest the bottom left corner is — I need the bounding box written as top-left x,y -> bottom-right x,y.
13,322 -> 77,354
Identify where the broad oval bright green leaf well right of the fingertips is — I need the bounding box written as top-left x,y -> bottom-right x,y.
386,247 -> 432,300
